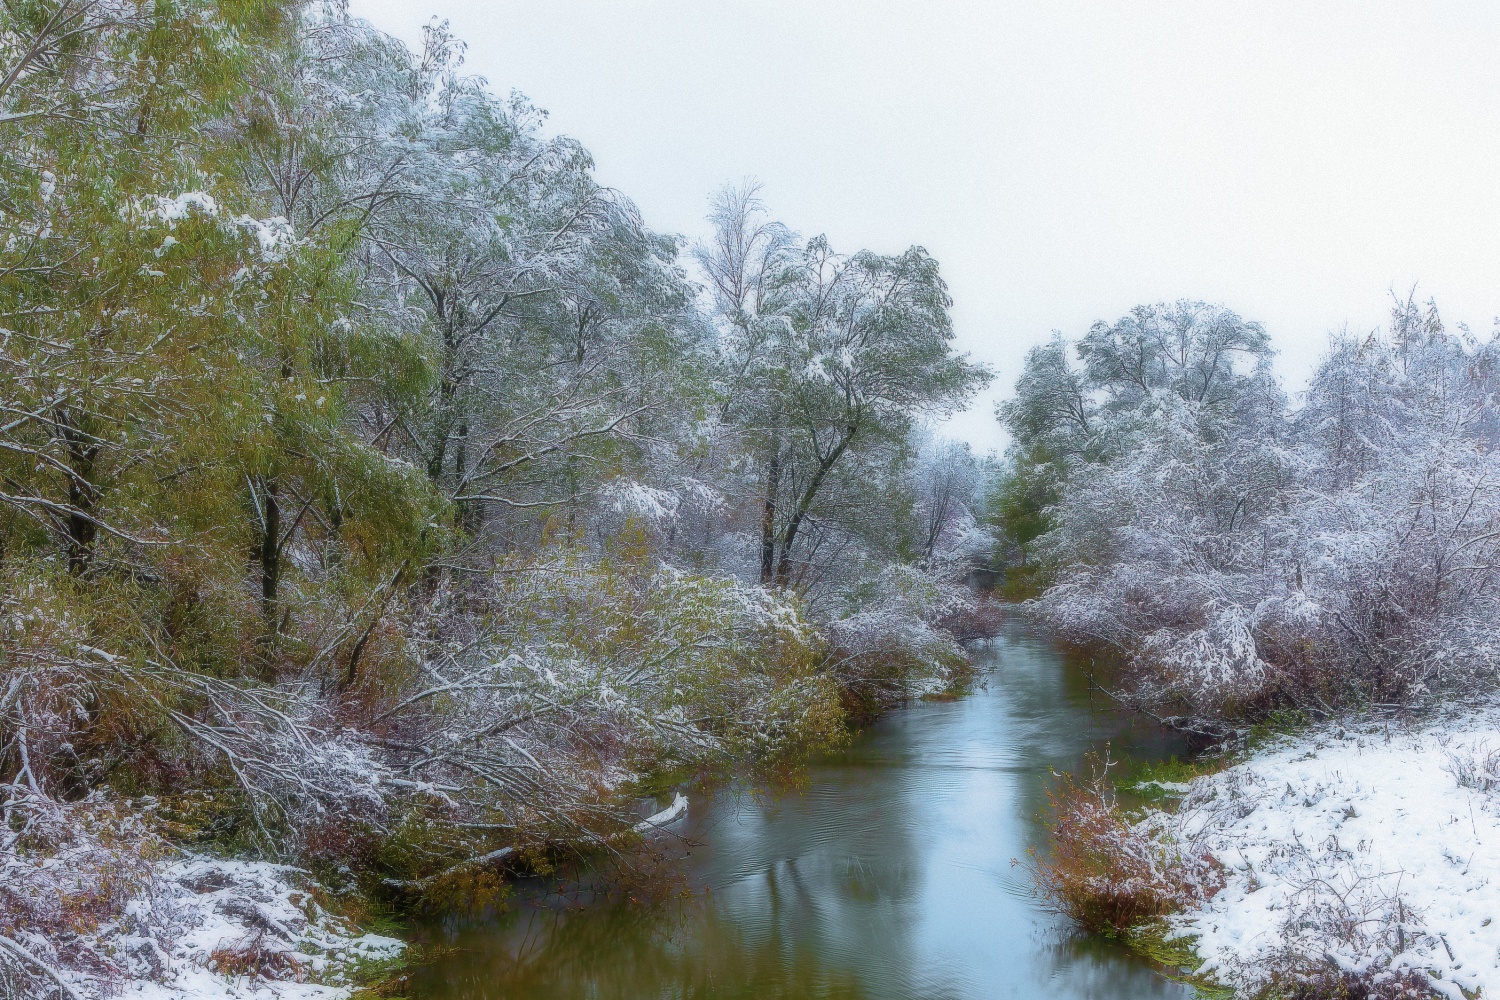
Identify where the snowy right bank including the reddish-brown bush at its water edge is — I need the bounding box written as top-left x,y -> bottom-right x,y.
1034,699 -> 1500,1000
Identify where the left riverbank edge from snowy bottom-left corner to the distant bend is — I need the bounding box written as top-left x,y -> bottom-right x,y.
0,611 -> 996,1000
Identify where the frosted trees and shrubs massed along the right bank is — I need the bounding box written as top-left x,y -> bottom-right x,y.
1002,296 -> 1500,729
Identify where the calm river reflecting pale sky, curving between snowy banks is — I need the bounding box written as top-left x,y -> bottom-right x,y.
411,622 -> 1194,1000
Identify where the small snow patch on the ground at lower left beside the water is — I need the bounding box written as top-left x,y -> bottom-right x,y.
43,856 -> 404,1000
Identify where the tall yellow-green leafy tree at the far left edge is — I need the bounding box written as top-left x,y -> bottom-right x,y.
0,0 -> 282,574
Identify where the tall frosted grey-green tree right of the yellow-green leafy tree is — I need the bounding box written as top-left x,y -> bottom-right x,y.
312,25 -> 693,531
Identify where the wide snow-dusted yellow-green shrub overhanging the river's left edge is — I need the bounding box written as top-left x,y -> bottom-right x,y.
352,549 -> 843,877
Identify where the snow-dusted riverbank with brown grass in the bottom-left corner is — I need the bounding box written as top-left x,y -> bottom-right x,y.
0,846 -> 405,1000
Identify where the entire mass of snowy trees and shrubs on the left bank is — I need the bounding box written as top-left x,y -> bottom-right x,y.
0,0 -> 992,997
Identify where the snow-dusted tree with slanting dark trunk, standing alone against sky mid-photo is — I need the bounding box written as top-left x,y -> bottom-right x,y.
699,187 -> 989,586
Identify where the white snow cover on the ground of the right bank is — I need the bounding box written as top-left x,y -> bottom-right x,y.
1173,703 -> 1500,1000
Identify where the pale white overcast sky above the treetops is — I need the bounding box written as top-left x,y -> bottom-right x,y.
351,0 -> 1500,450
